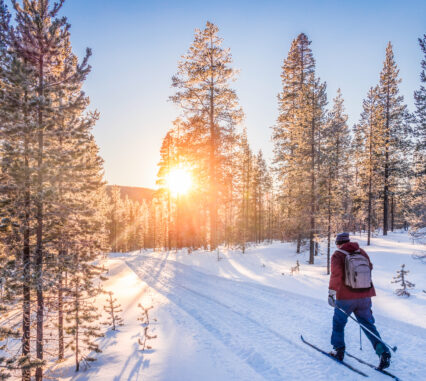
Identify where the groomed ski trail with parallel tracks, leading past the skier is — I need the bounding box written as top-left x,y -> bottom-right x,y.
126,253 -> 426,381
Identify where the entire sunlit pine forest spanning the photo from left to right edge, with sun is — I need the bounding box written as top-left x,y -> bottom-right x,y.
0,0 -> 426,381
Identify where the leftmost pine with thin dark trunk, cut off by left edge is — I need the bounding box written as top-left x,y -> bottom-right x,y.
1,3 -> 34,374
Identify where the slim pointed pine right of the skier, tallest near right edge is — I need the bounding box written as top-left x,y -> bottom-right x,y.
378,42 -> 411,235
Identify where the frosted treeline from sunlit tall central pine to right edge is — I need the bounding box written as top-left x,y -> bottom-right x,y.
150,22 -> 426,263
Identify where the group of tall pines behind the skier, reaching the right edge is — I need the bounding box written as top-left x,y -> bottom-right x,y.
273,34 -> 426,270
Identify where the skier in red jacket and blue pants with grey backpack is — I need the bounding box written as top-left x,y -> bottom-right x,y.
328,233 -> 391,369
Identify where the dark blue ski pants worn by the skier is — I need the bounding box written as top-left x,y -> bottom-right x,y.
331,298 -> 387,351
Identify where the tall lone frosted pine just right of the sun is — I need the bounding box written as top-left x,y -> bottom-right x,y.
171,22 -> 242,250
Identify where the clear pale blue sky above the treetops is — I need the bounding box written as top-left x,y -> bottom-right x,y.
26,0 -> 426,187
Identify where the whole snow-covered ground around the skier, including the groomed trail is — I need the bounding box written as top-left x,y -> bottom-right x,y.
49,233 -> 426,381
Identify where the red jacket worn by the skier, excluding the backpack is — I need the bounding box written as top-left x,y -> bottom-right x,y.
328,242 -> 376,300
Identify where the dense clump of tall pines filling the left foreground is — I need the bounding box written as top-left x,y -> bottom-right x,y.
0,0 -> 107,381
